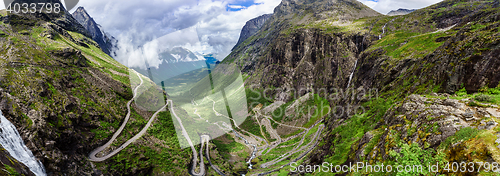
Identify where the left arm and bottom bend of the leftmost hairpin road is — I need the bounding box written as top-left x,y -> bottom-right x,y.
89,72 -> 144,162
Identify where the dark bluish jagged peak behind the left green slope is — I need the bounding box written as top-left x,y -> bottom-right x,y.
72,7 -> 117,55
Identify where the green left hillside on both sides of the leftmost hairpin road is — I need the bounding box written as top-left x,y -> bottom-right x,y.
0,8 -> 231,175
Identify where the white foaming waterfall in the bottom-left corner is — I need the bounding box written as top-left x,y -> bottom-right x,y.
0,111 -> 47,176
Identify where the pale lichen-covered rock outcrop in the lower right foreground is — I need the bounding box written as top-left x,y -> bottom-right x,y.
355,94 -> 500,164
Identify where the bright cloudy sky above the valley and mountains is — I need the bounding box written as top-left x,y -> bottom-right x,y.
0,0 -> 441,67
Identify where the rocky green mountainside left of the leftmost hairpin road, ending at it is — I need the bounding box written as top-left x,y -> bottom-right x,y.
0,4 -> 170,175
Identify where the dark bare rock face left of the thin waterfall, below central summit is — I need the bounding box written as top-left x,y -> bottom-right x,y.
257,30 -> 362,93
